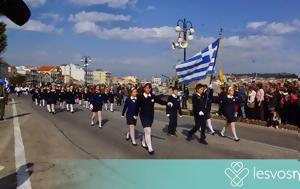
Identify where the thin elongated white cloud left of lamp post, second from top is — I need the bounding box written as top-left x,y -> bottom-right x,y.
69,11 -> 131,23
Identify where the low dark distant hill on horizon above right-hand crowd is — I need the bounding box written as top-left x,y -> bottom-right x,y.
231,73 -> 299,79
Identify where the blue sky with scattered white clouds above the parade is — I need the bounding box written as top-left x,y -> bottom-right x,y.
1,0 -> 300,79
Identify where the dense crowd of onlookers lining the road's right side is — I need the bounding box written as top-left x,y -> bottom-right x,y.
219,81 -> 300,127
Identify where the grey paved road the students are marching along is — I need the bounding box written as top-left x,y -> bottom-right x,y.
0,97 -> 300,189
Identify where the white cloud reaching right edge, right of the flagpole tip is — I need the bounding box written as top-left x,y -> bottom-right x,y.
247,19 -> 300,35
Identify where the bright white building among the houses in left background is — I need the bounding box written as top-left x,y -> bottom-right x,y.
60,64 -> 85,84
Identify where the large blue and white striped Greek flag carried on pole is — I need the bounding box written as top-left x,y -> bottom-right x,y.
176,40 -> 219,83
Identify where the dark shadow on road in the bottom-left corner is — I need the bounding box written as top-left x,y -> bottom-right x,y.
0,163 -> 34,189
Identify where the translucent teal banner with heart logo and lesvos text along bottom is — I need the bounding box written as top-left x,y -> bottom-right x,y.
57,160 -> 300,189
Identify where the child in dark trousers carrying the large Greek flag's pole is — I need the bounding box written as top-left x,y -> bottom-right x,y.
186,84 -> 208,145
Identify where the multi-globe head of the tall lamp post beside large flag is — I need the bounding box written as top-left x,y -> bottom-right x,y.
172,18 -> 195,61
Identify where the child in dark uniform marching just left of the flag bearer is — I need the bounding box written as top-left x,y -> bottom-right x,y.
166,87 -> 182,136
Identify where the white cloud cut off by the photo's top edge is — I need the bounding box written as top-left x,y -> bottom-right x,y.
69,0 -> 137,8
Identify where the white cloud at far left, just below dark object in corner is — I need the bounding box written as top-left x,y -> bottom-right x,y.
0,18 -> 63,33
